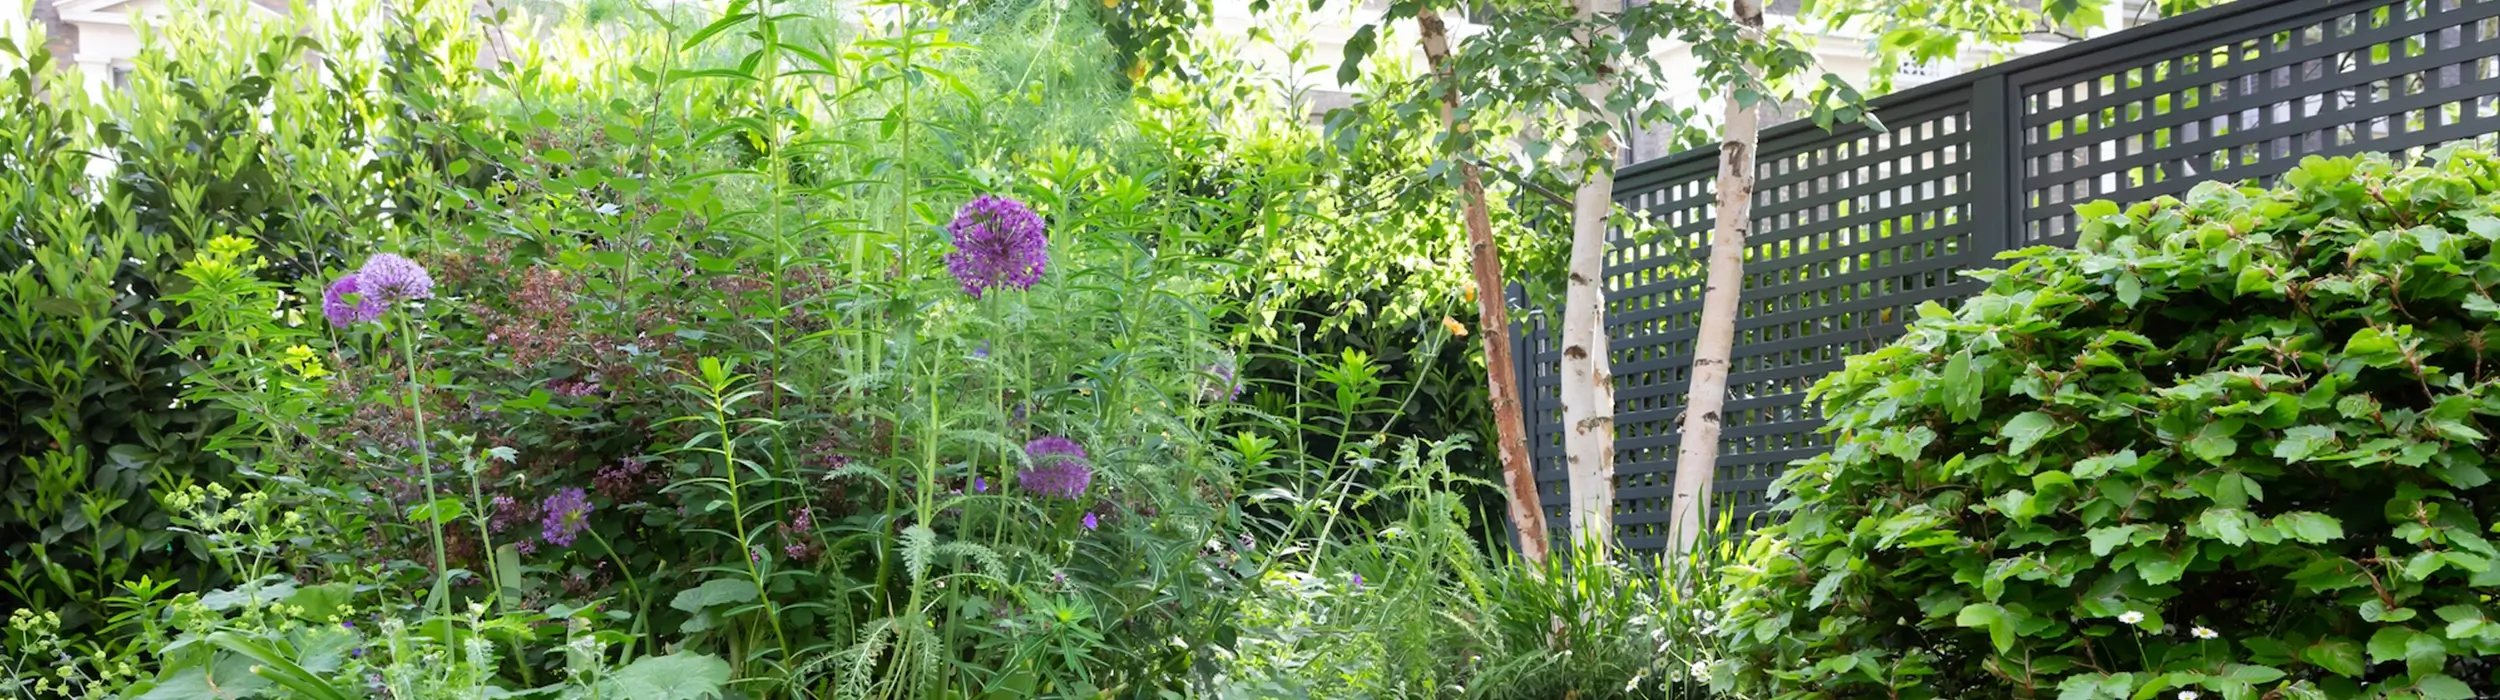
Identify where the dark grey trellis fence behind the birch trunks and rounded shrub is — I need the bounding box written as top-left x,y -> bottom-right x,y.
1518,0 -> 2500,550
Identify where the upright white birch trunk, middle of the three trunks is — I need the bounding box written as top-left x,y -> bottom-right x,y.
1563,0 -> 1615,558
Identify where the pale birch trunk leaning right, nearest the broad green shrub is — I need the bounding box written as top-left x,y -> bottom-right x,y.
1673,0 -> 1763,555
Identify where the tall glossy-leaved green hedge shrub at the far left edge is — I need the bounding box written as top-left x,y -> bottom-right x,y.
0,3 -> 428,645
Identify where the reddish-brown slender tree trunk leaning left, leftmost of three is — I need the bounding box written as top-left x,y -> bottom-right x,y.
1415,8 -> 1548,563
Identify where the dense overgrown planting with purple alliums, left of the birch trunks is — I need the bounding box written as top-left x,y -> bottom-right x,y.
0,3 -> 1690,698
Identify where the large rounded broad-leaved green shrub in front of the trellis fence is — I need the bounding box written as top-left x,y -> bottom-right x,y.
1713,153 -> 2500,700
